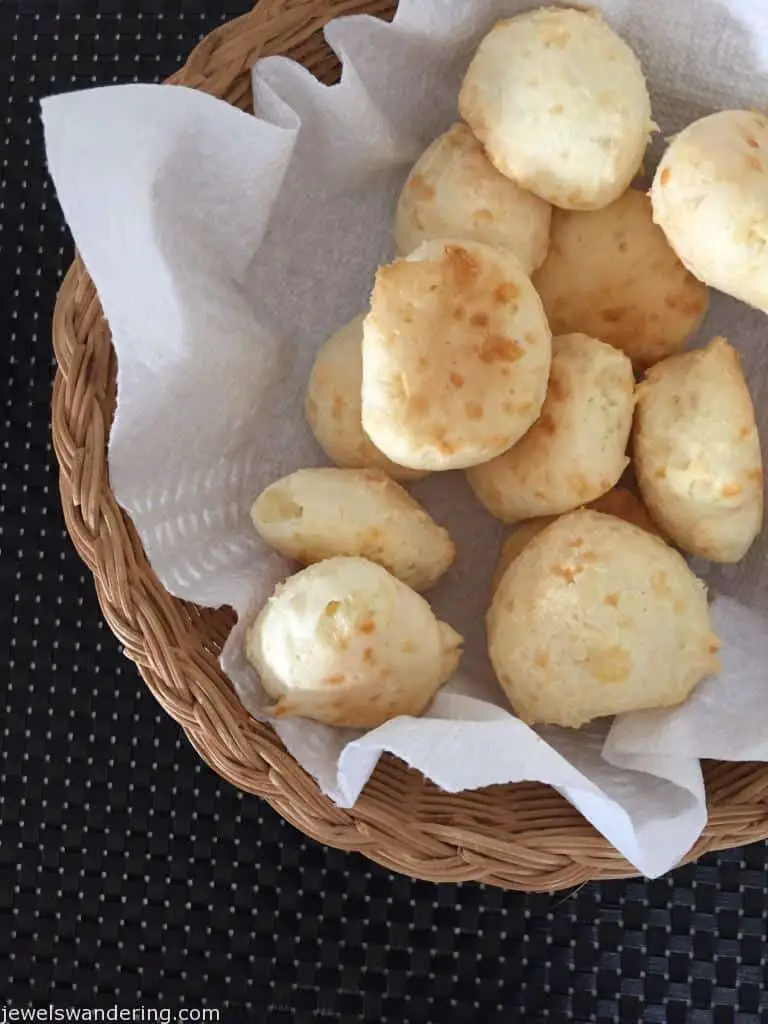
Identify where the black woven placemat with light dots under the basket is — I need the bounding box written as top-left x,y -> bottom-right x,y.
0,0 -> 768,1024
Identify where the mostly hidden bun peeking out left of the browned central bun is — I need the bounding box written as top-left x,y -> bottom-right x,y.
304,313 -> 424,480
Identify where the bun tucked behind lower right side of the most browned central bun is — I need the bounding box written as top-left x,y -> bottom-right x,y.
467,334 -> 635,522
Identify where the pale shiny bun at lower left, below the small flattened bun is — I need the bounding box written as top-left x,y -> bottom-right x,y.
246,558 -> 462,729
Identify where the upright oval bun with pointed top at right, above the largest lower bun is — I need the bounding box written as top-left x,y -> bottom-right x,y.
634,338 -> 763,562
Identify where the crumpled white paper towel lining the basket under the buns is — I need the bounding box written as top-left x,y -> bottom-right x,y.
43,0 -> 768,877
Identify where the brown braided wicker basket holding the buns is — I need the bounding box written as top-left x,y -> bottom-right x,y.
53,0 -> 768,890
